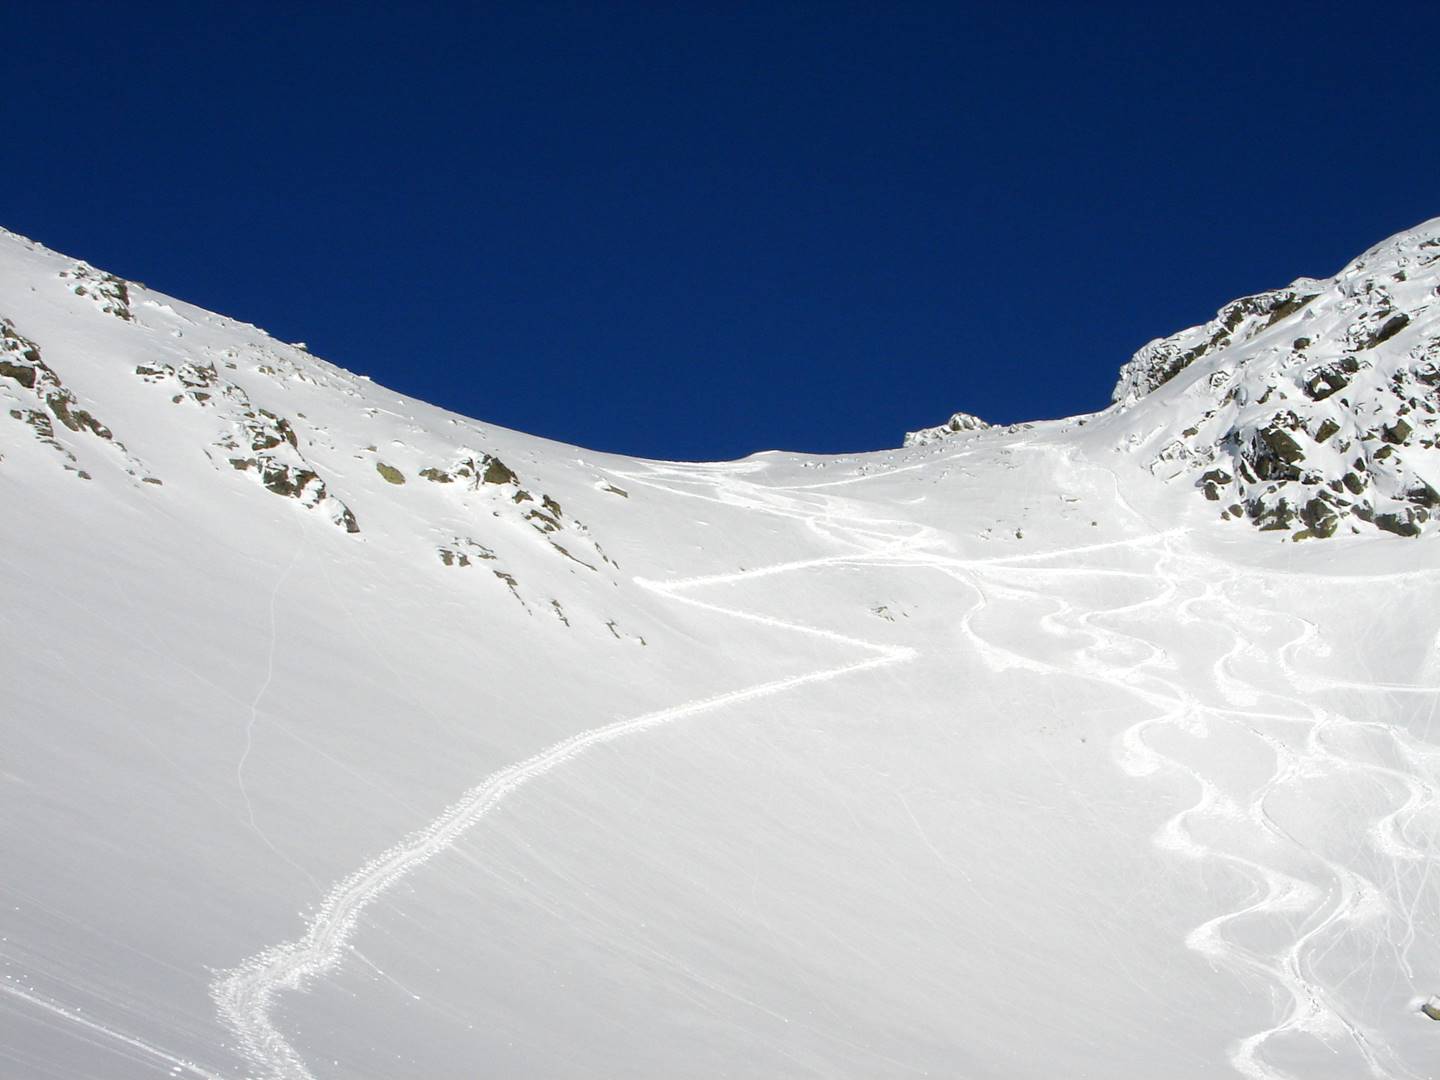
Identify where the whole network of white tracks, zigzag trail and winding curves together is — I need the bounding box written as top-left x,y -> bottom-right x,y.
212,443 -> 1440,1080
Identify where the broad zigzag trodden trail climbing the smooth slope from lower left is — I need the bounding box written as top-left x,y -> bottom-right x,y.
210,457 -> 930,1080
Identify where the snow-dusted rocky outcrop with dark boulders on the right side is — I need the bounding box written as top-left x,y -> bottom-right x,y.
1115,219 -> 1440,540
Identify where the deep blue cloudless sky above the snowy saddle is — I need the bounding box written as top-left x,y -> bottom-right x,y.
8,0 -> 1440,458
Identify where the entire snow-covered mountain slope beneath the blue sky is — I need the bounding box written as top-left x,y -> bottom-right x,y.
0,221 -> 1440,1080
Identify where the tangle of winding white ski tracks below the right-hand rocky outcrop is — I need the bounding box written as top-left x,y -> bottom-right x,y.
887,455 -> 1440,1080
